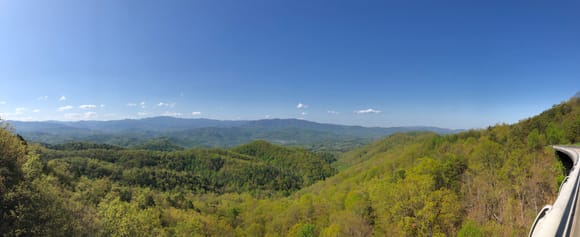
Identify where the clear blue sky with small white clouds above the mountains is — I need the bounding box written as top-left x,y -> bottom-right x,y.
0,0 -> 580,128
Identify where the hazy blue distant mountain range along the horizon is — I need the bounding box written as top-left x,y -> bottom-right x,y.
9,117 -> 460,151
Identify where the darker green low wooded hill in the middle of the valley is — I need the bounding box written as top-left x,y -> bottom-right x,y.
40,141 -> 335,195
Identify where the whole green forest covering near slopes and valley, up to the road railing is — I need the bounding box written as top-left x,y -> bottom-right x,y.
0,98 -> 580,236
